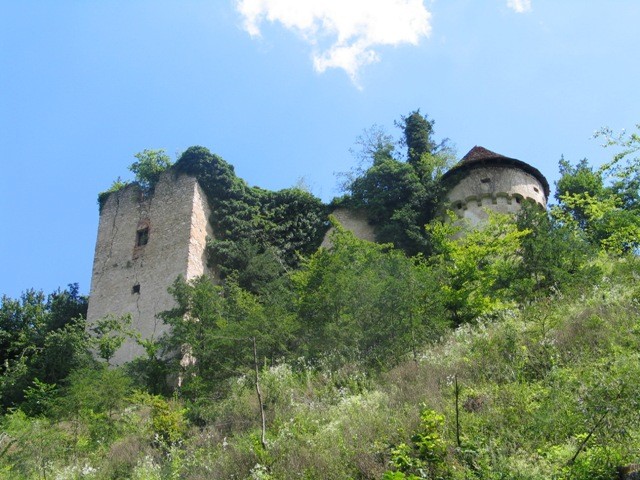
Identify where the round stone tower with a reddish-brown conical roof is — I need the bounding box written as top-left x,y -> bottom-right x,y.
442,146 -> 549,225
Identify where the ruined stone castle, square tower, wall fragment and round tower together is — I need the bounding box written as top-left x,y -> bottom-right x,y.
87,147 -> 549,365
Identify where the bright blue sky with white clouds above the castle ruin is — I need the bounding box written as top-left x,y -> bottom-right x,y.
0,0 -> 640,297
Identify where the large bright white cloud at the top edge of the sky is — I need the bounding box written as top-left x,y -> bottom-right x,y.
236,0 -> 431,84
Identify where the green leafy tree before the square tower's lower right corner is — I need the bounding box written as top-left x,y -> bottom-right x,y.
162,277 -> 291,399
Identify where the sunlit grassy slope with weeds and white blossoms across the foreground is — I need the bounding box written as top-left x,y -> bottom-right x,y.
0,258 -> 640,479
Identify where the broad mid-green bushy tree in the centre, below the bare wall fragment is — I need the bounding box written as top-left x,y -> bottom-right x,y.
292,225 -> 442,366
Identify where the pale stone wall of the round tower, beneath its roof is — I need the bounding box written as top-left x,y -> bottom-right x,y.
447,166 -> 547,225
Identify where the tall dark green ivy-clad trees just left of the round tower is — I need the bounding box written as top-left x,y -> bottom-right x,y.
343,111 -> 453,255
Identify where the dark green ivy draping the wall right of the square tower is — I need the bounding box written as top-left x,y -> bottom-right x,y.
176,147 -> 328,282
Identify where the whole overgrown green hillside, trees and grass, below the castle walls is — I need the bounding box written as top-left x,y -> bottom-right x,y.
0,122 -> 640,480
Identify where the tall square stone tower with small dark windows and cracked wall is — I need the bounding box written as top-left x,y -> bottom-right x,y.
87,171 -> 213,365
